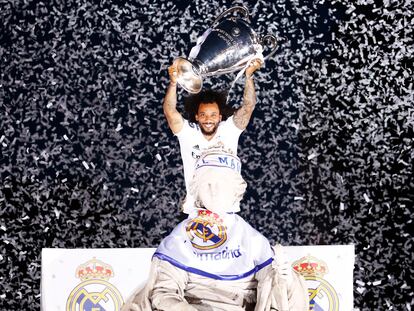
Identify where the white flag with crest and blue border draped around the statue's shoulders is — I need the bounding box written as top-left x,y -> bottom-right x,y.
154,210 -> 274,280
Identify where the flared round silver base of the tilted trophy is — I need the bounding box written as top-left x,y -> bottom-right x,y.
175,57 -> 203,94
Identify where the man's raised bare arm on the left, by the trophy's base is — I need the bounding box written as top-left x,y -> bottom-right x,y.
162,62 -> 184,134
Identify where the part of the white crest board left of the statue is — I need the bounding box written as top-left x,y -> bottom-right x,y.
41,248 -> 155,311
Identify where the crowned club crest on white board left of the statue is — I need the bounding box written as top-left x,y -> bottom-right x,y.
66,258 -> 124,311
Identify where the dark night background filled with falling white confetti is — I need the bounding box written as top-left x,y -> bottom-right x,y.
0,0 -> 414,310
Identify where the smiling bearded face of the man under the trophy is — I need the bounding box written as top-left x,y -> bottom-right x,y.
196,102 -> 221,136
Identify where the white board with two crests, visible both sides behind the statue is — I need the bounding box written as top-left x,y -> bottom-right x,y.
41,245 -> 354,311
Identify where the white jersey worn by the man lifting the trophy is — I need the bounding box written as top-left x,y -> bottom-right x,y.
175,116 -> 243,214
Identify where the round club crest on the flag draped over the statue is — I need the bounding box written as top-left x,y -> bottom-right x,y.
186,210 -> 227,250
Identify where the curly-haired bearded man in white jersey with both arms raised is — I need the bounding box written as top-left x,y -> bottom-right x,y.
163,59 -> 262,213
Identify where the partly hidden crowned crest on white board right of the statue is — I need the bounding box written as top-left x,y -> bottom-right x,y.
292,255 -> 339,311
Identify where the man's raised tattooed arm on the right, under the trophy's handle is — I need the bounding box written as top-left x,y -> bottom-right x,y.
233,59 -> 262,130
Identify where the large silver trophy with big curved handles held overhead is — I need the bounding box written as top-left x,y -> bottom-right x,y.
176,6 -> 277,94
